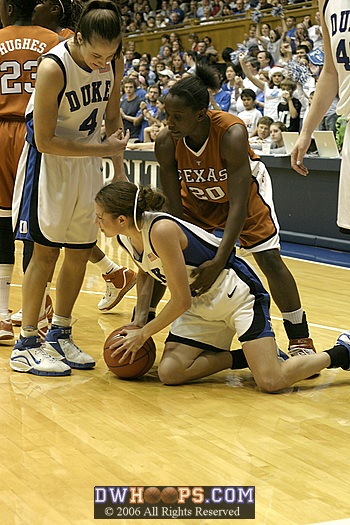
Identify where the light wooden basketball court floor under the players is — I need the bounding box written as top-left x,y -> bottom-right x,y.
0,235 -> 350,525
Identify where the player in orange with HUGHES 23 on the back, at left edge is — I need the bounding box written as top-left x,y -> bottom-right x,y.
0,0 -> 59,344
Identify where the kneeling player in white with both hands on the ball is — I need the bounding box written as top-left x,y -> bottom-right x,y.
95,181 -> 350,392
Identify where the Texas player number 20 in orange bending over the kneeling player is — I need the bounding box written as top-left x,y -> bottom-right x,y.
155,67 -> 315,355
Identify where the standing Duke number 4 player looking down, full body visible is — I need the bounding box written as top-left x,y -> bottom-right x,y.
10,0 -> 129,375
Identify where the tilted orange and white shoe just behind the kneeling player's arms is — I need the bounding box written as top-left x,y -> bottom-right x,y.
98,267 -> 137,311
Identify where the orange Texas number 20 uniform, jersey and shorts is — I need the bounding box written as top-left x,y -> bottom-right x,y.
175,110 -> 278,248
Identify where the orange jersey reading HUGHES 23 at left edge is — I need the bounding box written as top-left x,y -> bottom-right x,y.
0,26 -> 59,121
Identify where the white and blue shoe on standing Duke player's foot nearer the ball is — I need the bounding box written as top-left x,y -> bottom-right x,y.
44,326 -> 95,370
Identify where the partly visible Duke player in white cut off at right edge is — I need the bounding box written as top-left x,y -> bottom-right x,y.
292,0 -> 350,233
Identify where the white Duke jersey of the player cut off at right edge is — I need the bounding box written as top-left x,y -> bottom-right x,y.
323,0 -> 350,117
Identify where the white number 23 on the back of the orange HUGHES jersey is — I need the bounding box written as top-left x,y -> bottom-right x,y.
0,60 -> 37,95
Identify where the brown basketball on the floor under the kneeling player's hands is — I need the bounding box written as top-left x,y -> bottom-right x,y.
103,329 -> 156,379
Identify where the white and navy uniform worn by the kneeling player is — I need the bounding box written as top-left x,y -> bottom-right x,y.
117,212 -> 274,350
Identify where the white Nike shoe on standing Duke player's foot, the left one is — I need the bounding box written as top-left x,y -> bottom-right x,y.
10,335 -> 71,376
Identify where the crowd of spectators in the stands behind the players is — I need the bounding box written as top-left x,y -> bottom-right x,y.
121,0 -> 346,154
